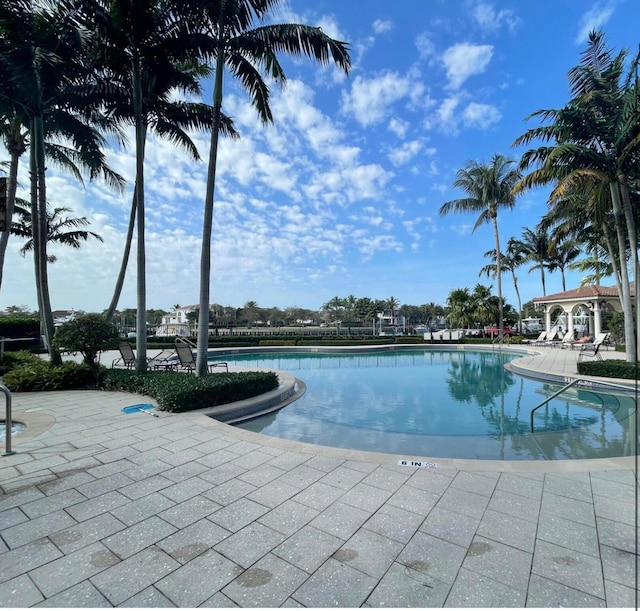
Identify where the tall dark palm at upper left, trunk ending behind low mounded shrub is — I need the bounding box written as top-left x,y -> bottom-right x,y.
0,0 -> 123,363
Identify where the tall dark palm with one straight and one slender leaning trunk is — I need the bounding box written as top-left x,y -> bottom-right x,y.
83,0 -> 234,371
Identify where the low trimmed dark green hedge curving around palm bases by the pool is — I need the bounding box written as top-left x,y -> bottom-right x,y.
104,369 -> 279,412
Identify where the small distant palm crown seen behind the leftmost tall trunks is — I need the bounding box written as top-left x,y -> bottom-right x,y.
11,205 -> 103,263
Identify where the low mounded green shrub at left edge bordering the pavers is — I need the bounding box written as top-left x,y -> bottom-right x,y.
2,357 -> 97,392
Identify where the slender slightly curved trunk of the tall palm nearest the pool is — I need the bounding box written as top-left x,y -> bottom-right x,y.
195,11 -> 224,377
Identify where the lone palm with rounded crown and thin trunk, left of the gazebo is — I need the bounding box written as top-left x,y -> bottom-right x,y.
440,154 -> 521,340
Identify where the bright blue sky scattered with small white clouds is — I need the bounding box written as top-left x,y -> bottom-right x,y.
0,0 -> 640,311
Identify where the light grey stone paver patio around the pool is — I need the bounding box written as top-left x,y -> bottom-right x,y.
0,349 -> 638,607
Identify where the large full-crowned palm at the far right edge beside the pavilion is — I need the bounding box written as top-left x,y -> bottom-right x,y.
514,32 -> 640,361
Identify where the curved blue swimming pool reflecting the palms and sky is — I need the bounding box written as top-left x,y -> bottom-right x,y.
219,349 -> 635,460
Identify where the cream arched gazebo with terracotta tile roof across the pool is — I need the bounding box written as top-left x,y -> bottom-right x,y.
533,285 -> 634,335
